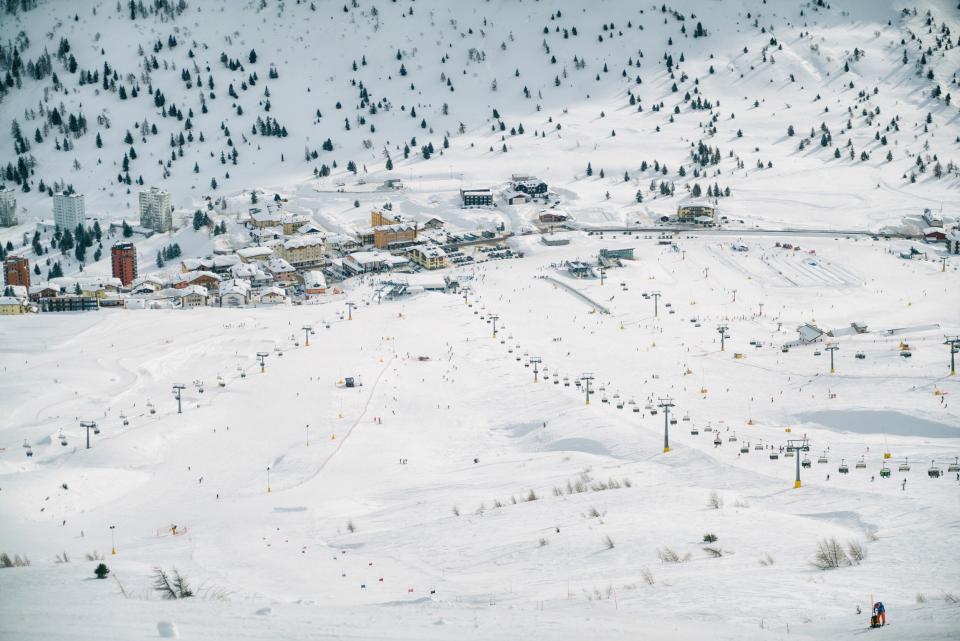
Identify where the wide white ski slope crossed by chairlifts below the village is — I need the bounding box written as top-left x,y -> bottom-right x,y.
0,233 -> 960,639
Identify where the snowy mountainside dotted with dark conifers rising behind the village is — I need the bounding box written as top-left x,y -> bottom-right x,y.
0,0 -> 960,232
